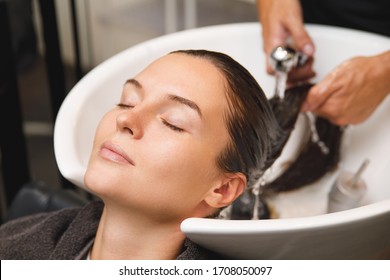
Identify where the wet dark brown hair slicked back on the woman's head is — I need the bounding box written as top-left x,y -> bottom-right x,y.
171,49 -> 280,185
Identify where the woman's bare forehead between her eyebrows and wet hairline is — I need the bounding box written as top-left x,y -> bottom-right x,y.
135,53 -> 227,114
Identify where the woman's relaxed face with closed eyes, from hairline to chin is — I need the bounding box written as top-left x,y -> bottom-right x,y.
85,54 -> 233,219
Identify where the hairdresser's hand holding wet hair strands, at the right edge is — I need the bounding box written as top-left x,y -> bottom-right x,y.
302,51 -> 390,125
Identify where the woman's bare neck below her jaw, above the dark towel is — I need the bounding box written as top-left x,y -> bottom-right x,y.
91,205 -> 185,260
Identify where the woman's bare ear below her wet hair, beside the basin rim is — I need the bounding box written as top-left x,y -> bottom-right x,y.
204,173 -> 246,208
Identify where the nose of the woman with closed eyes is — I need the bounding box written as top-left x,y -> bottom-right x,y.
116,108 -> 143,139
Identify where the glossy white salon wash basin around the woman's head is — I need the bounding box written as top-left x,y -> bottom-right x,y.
54,22 -> 390,259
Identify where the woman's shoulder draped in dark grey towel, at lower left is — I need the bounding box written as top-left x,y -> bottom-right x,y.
0,202 -> 103,259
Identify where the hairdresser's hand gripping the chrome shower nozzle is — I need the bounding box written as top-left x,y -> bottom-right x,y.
257,0 -> 315,83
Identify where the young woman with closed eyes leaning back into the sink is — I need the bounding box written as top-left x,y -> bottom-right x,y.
0,50 -> 278,259
